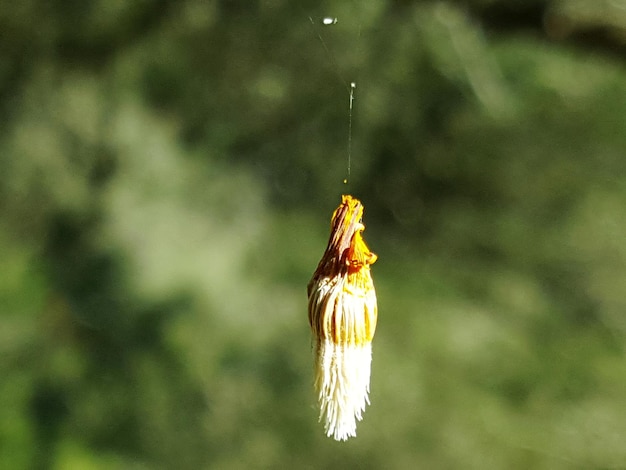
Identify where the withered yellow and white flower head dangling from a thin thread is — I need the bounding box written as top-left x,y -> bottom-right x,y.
307,195 -> 378,441
